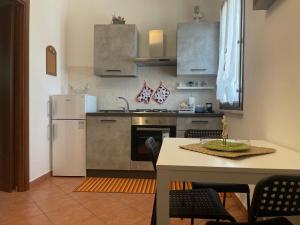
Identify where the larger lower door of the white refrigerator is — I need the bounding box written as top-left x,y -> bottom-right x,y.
52,120 -> 86,176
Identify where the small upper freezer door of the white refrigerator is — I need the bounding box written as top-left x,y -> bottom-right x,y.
51,95 -> 86,120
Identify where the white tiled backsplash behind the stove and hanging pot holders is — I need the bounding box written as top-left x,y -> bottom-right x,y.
68,67 -> 218,110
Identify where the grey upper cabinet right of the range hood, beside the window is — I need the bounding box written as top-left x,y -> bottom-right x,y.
177,22 -> 220,75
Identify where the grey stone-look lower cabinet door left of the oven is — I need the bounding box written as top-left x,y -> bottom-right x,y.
87,117 -> 131,170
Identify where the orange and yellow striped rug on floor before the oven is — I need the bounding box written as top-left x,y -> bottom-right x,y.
74,177 -> 192,194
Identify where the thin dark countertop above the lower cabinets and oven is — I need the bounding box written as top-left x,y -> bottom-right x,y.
86,110 -> 224,117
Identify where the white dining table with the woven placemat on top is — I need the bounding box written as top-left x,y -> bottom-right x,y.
156,138 -> 300,225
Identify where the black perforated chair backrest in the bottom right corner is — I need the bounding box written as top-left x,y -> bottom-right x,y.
249,175 -> 300,224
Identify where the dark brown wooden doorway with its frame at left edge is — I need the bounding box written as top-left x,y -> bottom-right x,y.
0,0 -> 29,192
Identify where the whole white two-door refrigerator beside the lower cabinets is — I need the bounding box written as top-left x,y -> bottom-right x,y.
50,95 -> 97,176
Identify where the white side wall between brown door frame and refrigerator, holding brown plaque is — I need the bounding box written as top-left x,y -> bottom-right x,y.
29,0 -> 67,181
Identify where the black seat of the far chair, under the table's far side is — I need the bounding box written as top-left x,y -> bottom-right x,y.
192,182 -> 250,193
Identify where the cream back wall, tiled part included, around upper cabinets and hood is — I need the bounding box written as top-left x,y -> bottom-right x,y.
67,0 -> 221,109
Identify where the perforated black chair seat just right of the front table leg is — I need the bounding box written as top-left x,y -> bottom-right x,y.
170,188 -> 235,222
